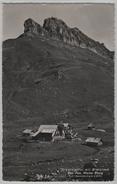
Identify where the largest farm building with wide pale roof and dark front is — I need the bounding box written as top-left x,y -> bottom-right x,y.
32,125 -> 63,141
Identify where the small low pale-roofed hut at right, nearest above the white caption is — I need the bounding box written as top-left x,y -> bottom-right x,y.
85,137 -> 103,146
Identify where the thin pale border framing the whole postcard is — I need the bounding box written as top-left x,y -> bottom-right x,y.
0,0 -> 117,184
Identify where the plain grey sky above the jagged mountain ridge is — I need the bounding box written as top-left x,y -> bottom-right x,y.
3,3 -> 114,50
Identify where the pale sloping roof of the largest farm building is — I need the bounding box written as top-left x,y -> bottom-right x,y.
33,125 -> 58,137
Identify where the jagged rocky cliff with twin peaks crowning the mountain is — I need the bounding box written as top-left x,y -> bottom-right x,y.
23,17 -> 113,58
